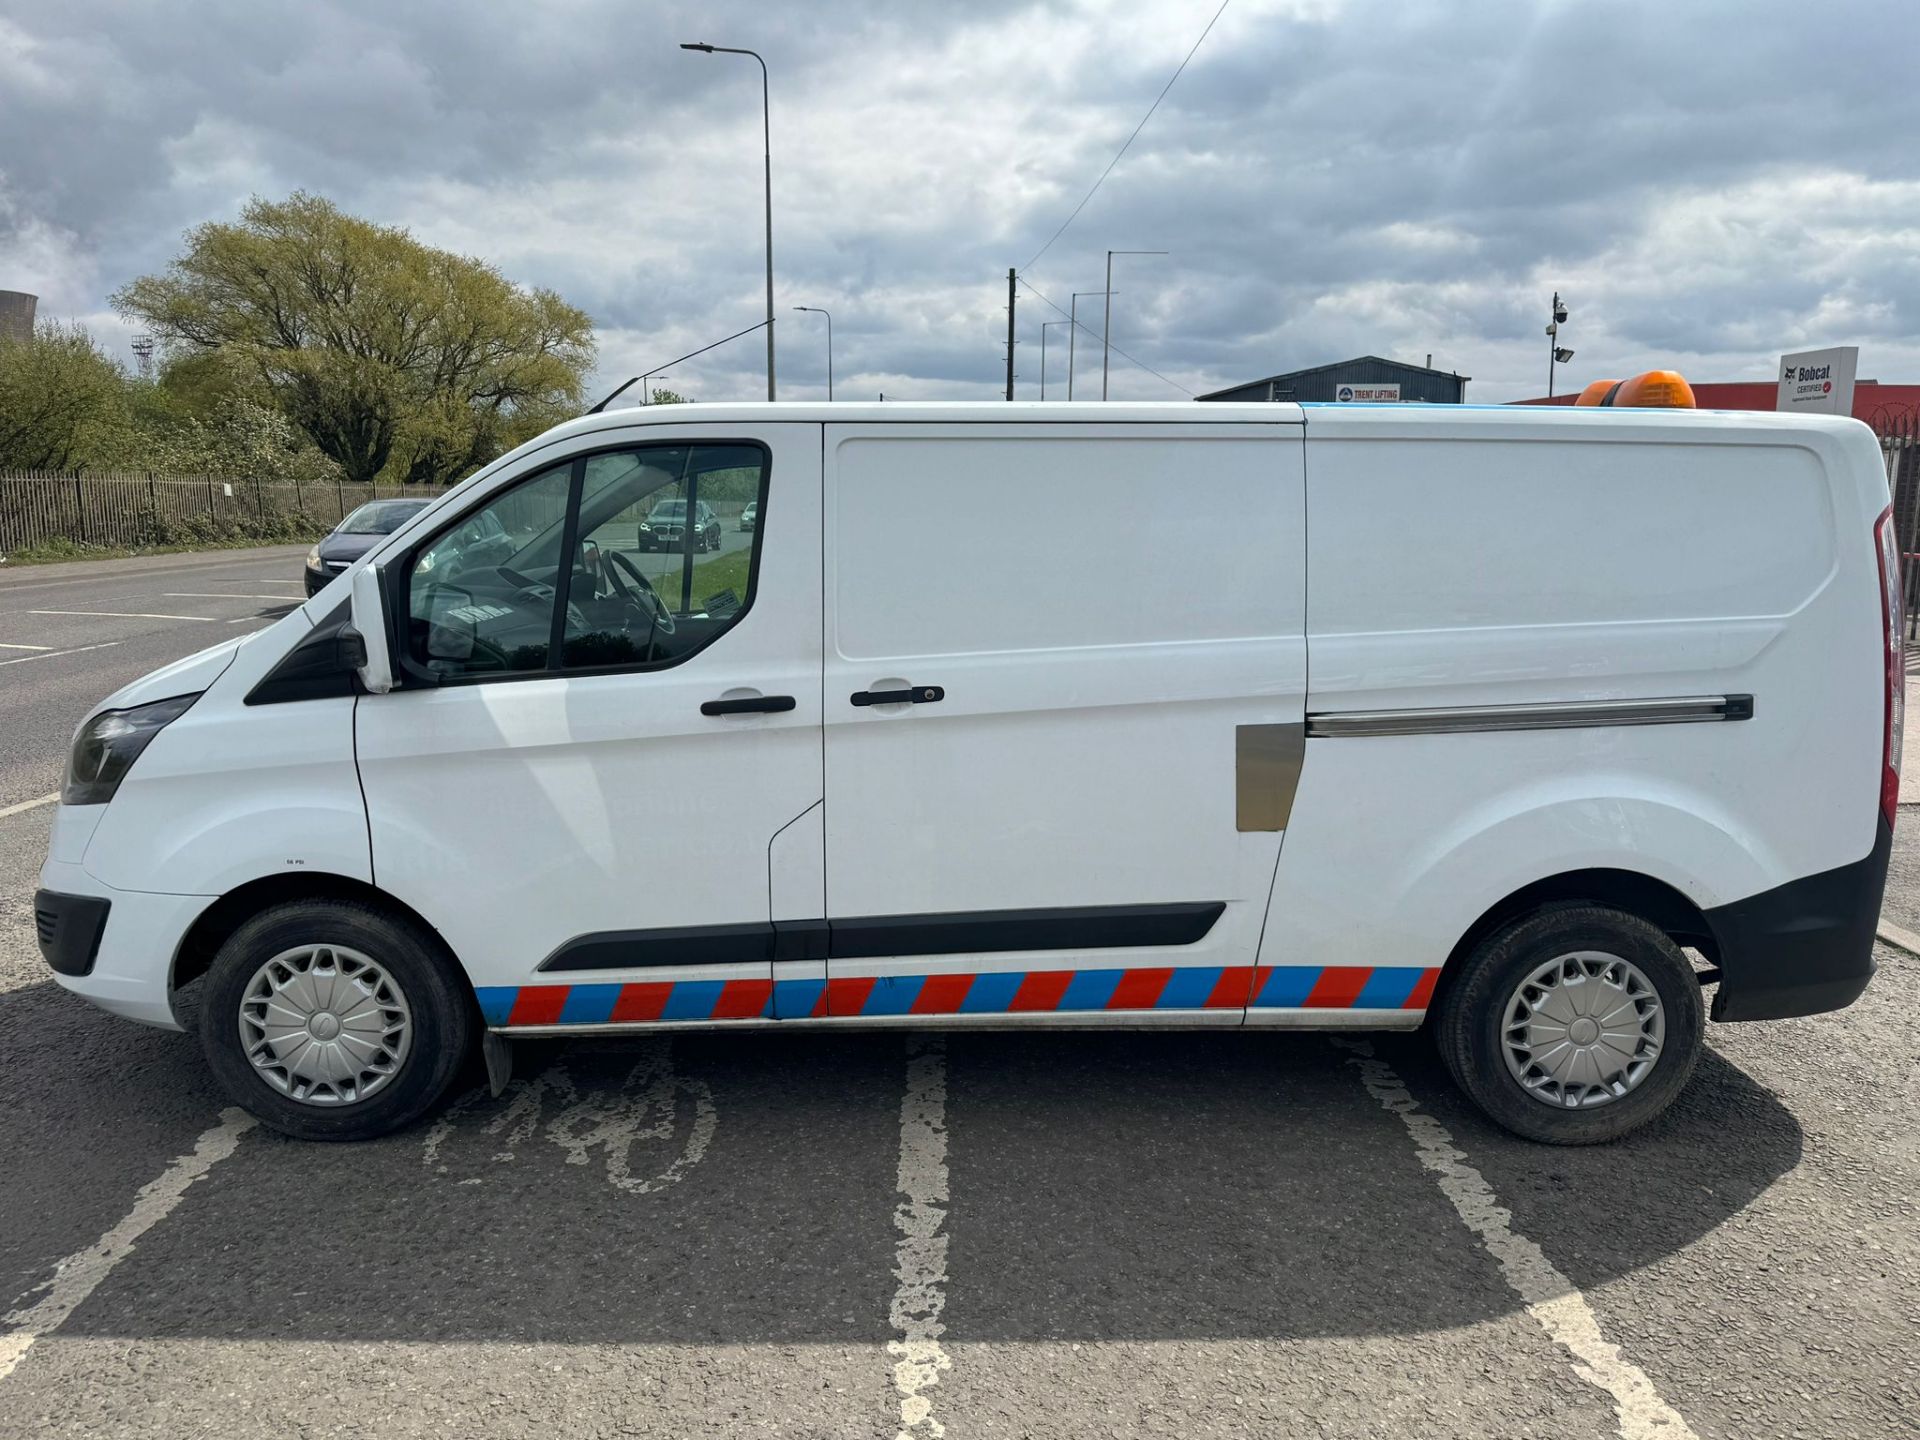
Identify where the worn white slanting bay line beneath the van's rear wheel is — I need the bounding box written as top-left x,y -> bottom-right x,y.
1334,1039 -> 1699,1440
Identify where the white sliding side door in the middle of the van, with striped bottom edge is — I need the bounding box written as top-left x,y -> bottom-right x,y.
824,422 -> 1306,1025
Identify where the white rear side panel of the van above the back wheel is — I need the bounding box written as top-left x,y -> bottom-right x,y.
1261,411 -> 1885,1006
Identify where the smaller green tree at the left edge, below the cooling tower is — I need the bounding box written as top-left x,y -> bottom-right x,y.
0,321 -> 132,470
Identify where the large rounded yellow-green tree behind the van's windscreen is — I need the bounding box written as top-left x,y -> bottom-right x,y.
113,194 -> 593,482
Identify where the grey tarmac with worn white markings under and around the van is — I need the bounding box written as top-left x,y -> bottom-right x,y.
0,553 -> 1920,1440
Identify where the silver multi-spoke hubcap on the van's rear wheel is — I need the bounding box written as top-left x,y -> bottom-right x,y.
1500,950 -> 1667,1110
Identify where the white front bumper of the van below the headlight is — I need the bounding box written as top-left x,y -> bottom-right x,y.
35,860 -> 215,1029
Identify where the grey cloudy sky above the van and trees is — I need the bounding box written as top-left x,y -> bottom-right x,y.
0,0 -> 1920,401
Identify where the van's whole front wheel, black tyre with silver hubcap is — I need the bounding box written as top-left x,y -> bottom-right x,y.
200,899 -> 480,1140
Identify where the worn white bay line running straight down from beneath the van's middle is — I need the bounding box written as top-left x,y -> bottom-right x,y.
887,1035 -> 952,1440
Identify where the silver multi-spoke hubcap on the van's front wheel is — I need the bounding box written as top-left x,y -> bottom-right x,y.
238,945 -> 413,1106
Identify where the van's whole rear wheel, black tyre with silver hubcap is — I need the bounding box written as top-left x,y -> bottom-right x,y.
1434,904 -> 1705,1144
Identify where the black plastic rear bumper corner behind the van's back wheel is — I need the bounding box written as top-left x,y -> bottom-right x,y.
1707,820 -> 1893,1020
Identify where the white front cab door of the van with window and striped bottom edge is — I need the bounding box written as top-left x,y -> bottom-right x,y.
355,424 -> 824,1031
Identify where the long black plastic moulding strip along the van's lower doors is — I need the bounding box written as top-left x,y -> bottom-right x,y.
540,900 -> 1227,972
